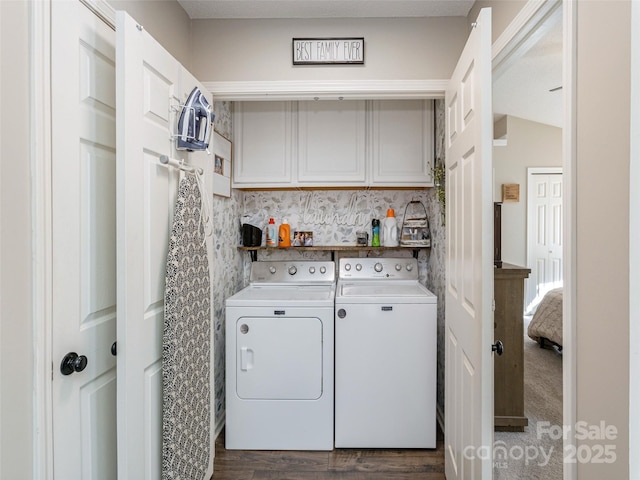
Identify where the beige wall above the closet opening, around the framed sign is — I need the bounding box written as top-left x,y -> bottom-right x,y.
192,17 -> 467,82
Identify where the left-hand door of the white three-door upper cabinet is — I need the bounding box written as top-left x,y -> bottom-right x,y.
233,101 -> 293,188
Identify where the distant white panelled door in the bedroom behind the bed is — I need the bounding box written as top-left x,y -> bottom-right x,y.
525,168 -> 562,311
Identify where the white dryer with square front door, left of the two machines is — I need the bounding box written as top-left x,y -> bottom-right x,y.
225,261 -> 336,450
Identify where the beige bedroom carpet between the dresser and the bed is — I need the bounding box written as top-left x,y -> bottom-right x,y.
493,337 -> 562,480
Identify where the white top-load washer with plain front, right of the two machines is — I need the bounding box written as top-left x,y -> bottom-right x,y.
335,258 -> 437,448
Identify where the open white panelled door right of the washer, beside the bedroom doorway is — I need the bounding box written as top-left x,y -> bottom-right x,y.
445,9 -> 493,480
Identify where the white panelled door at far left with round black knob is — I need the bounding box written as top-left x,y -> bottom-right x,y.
51,2 -> 117,480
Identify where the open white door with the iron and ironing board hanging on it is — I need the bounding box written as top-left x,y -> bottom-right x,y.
116,12 -> 214,480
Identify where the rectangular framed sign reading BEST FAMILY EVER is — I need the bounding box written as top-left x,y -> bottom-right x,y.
293,37 -> 364,65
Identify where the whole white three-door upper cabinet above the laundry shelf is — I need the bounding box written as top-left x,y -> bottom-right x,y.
232,100 -> 434,188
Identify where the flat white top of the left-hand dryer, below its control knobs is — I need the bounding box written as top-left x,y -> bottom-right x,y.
226,284 -> 335,307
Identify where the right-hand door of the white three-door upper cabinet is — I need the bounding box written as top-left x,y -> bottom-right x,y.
371,100 -> 434,187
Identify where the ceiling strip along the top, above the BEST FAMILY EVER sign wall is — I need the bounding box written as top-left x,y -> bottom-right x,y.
178,0 -> 475,19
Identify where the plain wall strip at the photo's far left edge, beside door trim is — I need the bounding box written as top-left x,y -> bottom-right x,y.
0,1 -> 34,480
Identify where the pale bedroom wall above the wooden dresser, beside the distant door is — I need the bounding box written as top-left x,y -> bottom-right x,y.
493,116 -> 562,266
